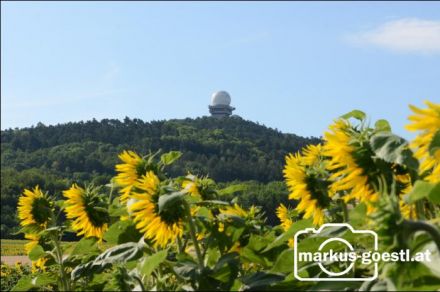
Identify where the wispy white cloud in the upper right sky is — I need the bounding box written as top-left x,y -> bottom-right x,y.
348,18 -> 440,54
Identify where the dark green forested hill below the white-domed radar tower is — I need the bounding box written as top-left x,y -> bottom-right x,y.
1,117 -> 319,234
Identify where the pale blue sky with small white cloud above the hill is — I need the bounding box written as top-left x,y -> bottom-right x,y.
1,2 -> 440,136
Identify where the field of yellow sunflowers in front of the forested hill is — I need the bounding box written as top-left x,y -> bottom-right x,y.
2,102 -> 440,291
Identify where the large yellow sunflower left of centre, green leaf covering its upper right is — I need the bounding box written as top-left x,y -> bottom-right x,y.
128,171 -> 185,247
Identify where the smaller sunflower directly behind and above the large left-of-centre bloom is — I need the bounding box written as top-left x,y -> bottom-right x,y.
115,151 -> 146,203
